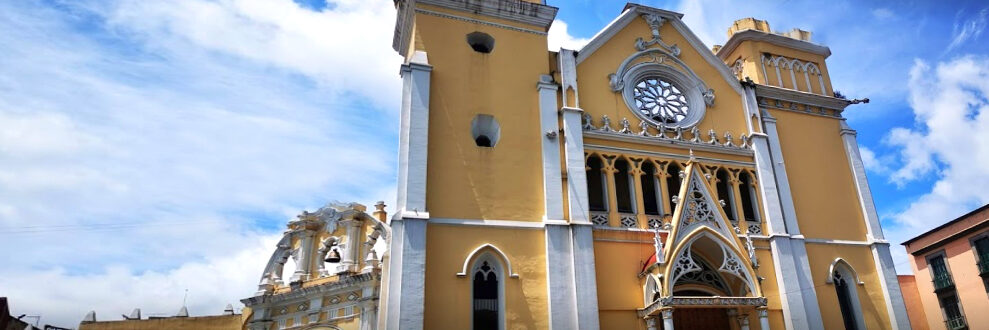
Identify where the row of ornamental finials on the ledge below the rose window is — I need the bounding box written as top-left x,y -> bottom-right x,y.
583,112 -> 751,150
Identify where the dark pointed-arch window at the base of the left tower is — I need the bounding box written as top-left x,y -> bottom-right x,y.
471,254 -> 504,330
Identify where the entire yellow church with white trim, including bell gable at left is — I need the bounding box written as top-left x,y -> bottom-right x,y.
80,0 -> 910,330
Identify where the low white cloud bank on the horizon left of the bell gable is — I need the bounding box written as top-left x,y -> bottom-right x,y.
0,235 -> 279,327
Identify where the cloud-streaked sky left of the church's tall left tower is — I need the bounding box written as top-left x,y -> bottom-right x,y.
0,0 -> 401,327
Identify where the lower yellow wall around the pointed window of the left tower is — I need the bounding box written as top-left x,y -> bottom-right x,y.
424,224 -> 552,329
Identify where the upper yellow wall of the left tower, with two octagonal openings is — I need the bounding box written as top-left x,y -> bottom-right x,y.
416,8 -> 550,221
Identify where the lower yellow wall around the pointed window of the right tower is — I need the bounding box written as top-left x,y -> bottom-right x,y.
807,243 -> 896,329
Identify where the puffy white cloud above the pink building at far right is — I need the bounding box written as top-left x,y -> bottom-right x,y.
886,56 -> 989,272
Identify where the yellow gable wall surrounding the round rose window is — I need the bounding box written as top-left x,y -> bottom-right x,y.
577,19 -> 748,147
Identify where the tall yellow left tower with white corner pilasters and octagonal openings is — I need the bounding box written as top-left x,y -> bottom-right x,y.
380,0 -> 576,329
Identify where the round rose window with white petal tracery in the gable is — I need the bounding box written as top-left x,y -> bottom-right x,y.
632,76 -> 690,124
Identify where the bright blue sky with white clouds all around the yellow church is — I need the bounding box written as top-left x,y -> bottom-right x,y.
0,0 -> 989,326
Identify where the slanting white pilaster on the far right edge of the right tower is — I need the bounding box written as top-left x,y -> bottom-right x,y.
841,120 -> 910,329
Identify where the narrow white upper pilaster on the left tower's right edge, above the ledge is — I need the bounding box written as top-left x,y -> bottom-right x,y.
537,75 -> 563,220
